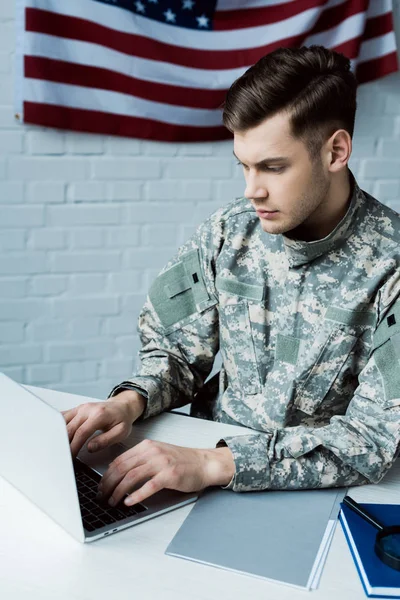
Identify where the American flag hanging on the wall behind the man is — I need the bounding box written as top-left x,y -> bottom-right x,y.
16,0 -> 398,141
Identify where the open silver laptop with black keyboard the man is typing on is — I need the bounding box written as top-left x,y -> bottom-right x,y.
0,373 -> 198,542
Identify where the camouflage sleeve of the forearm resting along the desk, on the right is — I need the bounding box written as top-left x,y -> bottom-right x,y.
219,284 -> 400,491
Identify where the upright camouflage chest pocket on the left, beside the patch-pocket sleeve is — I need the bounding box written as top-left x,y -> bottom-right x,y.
216,277 -> 264,395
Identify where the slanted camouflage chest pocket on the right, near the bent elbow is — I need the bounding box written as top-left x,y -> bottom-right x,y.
294,307 -> 373,415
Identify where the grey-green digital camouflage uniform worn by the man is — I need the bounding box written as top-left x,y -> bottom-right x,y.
112,173 -> 400,491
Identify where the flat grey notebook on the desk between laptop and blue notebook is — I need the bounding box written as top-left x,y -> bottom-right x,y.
166,488 -> 346,589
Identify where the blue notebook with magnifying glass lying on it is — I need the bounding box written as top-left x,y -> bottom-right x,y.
339,504 -> 400,598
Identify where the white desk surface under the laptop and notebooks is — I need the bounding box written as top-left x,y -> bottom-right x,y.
0,388 -> 400,600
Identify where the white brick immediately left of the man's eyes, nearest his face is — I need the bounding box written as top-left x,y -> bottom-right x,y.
164,157 -> 232,179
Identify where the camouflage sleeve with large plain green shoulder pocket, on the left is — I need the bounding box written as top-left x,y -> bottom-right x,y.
110,213 -> 222,419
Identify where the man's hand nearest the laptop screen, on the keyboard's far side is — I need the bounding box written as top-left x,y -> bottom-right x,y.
62,390 -> 146,457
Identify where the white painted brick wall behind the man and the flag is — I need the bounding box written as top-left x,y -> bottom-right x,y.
0,0 -> 400,397
